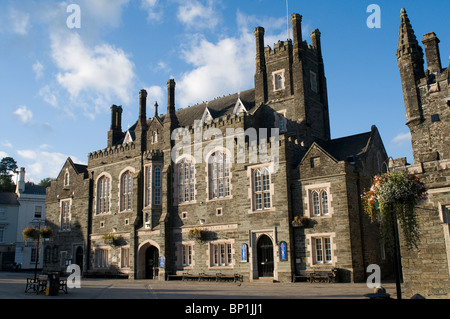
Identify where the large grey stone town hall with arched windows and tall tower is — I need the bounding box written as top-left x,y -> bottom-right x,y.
44,14 -> 390,281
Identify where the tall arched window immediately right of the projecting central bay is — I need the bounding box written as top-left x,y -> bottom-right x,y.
176,158 -> 195,203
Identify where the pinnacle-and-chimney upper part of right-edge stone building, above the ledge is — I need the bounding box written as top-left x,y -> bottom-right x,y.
397,9 -> 450,163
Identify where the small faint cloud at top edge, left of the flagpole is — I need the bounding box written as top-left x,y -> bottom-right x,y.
177,0 -> 219,29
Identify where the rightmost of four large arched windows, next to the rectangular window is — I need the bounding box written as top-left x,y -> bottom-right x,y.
208,151 -> 230,199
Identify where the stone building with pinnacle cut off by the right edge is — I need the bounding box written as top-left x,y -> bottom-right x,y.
391,9 -> 450,299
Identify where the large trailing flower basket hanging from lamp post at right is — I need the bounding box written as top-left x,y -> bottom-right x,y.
361,171 -> 428,249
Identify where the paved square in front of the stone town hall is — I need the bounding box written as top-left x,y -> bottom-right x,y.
0,272 -> 396,301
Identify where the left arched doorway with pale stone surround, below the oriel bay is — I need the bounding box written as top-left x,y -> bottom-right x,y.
136,241 -> 159,279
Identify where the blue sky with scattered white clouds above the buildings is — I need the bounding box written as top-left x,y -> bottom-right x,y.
0,0 -> 450,182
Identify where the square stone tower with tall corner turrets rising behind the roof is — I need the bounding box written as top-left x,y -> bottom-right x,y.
255,14 -> 330,146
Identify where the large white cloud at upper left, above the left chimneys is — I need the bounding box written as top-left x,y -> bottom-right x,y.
50,32 -> 135,117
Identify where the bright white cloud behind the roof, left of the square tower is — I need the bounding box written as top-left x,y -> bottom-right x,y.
177,11 -> 286,107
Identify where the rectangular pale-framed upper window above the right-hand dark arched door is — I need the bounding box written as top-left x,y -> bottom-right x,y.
252,167 -> 272,211
